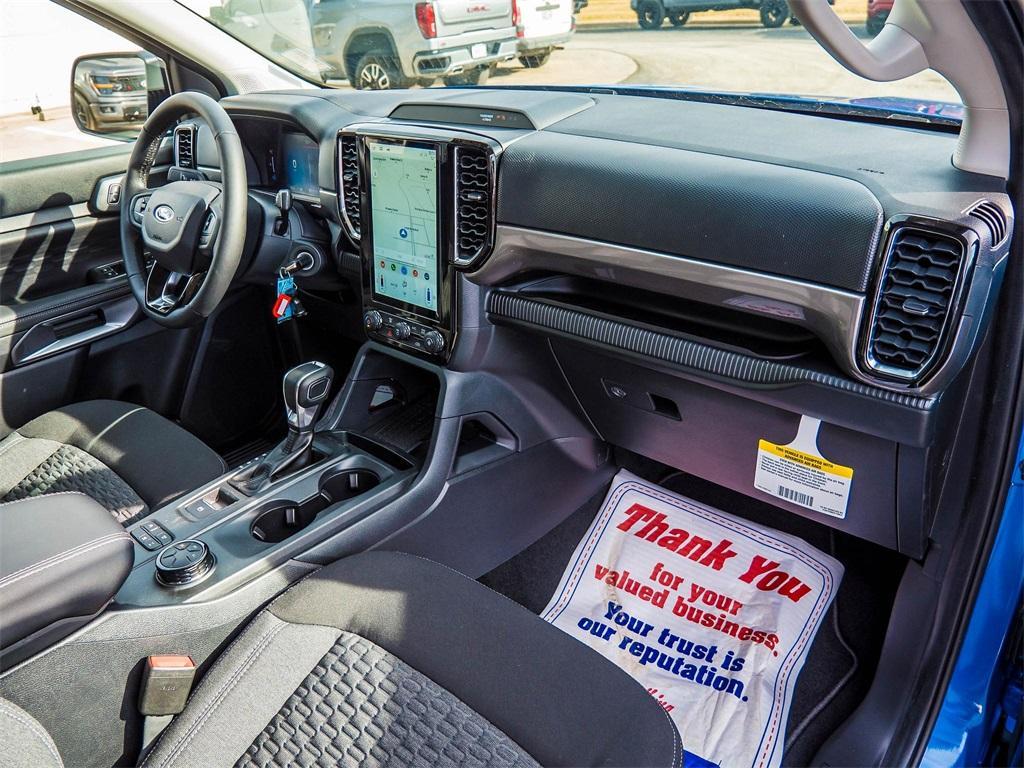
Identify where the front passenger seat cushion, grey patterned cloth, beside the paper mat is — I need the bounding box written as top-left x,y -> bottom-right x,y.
144,552 -> 682,768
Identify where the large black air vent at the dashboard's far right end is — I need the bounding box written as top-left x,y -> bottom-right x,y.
866,225 -> 965,382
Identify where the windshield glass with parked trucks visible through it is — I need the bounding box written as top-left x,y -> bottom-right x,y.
177,0 -> 963,122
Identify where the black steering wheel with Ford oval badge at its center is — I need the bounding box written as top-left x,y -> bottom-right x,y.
121,91 -> 249,328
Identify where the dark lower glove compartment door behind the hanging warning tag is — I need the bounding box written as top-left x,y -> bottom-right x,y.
550,338 -> 900,549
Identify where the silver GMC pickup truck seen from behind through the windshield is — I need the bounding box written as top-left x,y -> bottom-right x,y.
310,0 -> 517,89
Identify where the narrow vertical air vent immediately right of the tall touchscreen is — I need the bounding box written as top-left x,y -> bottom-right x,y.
455,146 -> 495,266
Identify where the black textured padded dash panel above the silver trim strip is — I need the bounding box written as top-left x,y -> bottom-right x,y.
498,132 -> 883,291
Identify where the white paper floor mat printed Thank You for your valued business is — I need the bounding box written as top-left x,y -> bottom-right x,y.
541,471 -> 843,768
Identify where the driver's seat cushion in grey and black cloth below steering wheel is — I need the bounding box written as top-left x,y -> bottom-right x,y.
0,400 -> 227,525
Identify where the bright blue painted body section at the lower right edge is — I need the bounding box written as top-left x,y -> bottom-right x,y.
922,435 -> 1024,768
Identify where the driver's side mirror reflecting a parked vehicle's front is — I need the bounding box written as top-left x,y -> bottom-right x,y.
71,51 -> 168,140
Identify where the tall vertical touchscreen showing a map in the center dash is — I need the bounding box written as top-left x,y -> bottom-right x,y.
367,139 -> 438,314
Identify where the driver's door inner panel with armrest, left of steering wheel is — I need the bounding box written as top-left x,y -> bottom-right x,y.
0,144 -> 175,434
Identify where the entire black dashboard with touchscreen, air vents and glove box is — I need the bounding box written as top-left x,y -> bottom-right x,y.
172,89 -> 1013,556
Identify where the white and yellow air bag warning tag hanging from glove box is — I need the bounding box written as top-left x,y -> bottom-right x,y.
754,425 -> 853,518
